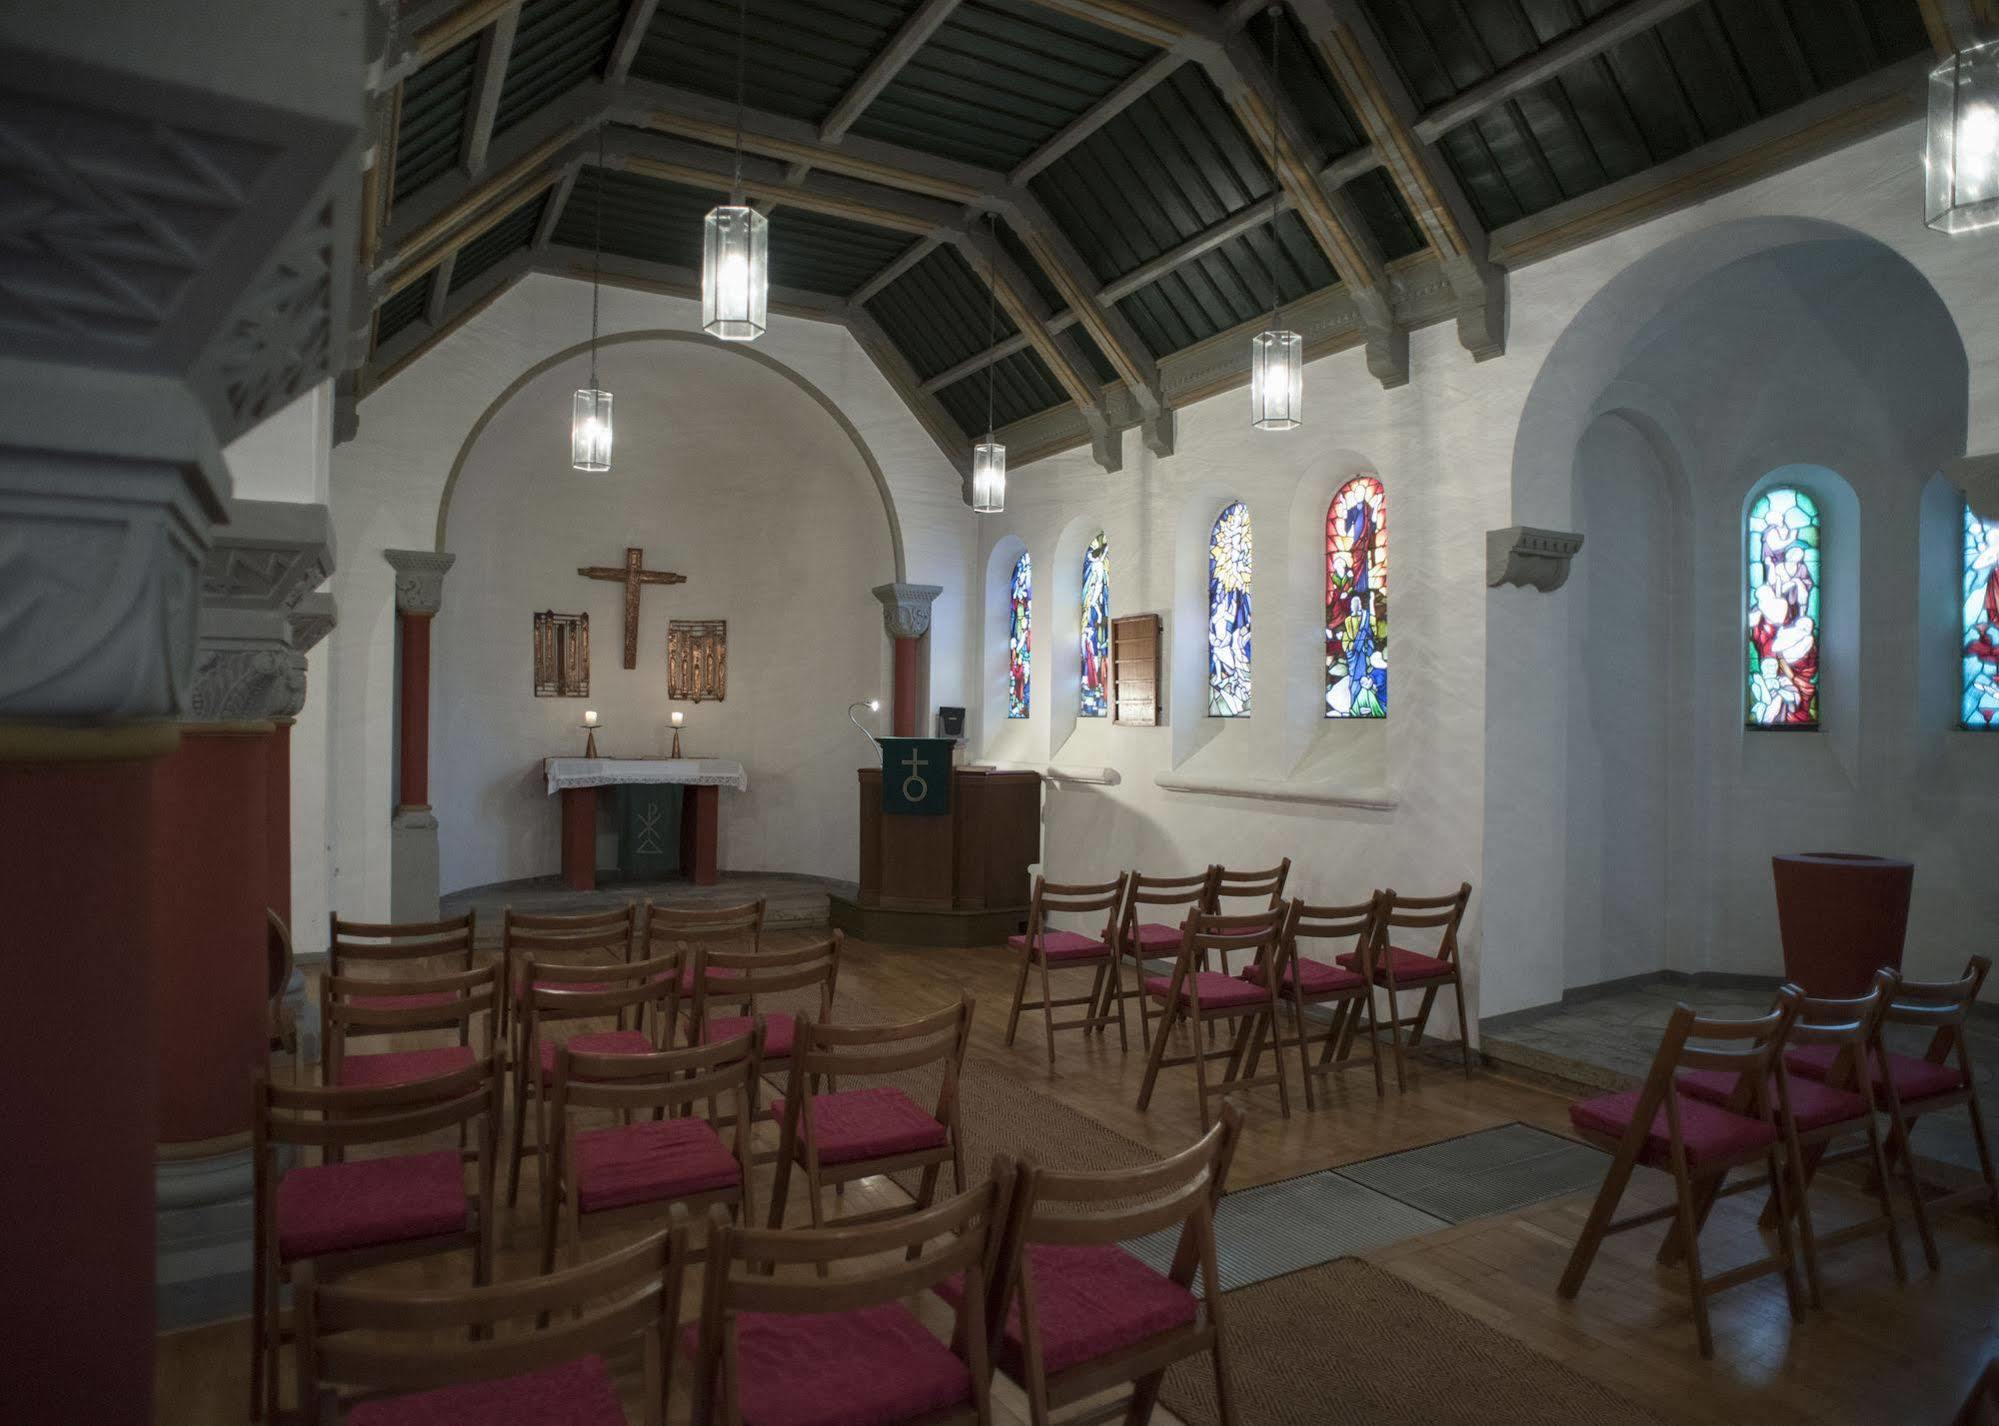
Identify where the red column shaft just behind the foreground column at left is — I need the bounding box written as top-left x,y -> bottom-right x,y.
144,722 -> 270,1144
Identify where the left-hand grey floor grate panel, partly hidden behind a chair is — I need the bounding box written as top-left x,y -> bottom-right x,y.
1125,1172 -> 1449,1292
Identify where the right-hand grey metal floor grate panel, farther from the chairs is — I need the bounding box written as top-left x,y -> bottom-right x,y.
1333,1124 -> 1609,1224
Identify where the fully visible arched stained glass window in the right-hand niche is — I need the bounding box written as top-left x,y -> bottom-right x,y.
1749,486 -> 1819,728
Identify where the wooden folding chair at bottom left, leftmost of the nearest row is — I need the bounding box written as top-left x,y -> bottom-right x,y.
298,1214 -> 688,1426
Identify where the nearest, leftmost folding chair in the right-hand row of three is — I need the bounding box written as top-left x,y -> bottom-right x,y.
1559,986 -> 1805,1358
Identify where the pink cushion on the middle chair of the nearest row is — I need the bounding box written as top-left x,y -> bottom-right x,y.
682,1302 -> 972,1426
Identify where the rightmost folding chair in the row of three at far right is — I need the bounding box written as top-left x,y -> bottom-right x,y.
1785,956 -> 1999,1272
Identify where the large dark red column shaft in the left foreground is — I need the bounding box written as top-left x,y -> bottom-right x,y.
0,724 -> 174,1426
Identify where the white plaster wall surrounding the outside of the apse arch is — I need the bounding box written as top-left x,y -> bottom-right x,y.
328,276 -> 974,918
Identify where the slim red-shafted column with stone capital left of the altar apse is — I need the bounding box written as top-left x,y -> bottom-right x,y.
382,550 -> 458,922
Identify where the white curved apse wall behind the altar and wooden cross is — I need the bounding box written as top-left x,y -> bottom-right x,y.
443,340 -> 896,892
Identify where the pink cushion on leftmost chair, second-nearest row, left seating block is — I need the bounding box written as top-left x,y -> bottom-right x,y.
278,1148 -> 470,1262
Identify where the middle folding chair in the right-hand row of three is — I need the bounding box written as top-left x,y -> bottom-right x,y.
1679,972 -> 1909,1306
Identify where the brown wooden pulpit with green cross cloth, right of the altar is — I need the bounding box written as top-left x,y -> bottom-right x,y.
836,768 -> 1041,946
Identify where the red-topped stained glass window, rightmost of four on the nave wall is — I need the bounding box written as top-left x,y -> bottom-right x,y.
1325,476 -> 1387,718
